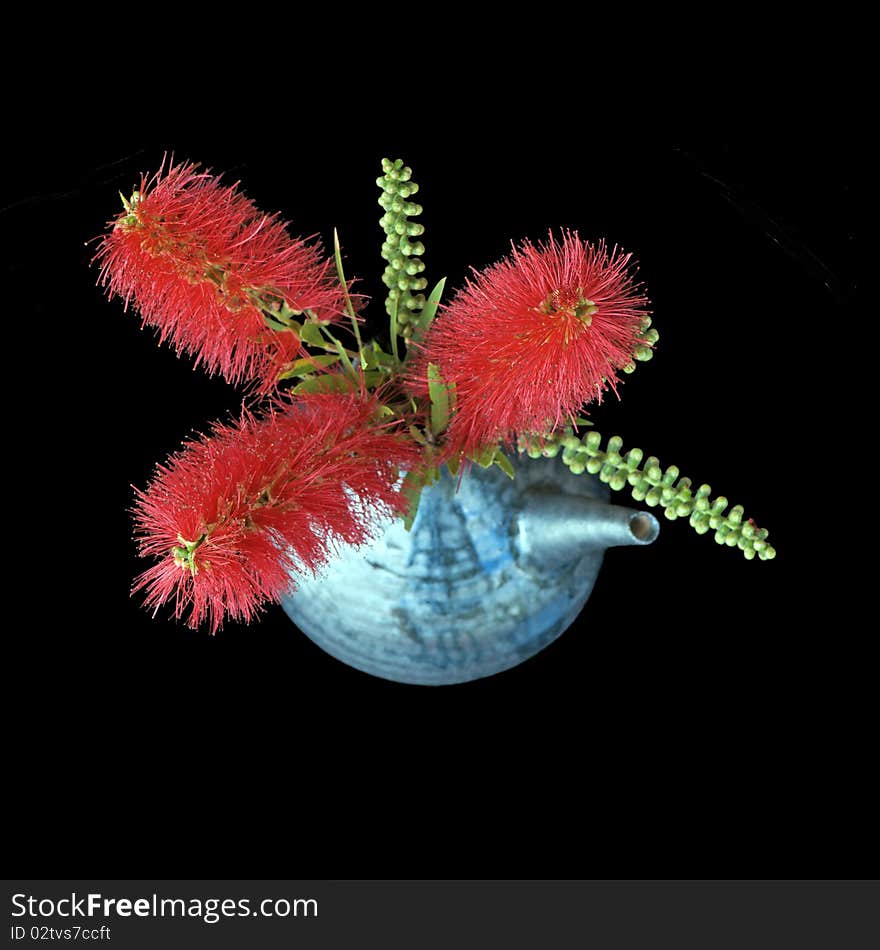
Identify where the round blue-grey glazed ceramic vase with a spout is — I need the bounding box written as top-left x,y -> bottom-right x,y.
283,458 -> 659,685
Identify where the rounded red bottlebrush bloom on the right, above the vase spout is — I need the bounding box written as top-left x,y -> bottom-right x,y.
414,231 -> 649,454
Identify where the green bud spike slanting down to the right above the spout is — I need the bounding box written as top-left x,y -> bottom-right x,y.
520,427 -> 776,561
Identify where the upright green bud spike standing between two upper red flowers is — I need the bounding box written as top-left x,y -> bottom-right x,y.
376,158 -> 428,337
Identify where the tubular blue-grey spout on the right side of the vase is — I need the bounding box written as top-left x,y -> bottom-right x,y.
513,490 -> 660,570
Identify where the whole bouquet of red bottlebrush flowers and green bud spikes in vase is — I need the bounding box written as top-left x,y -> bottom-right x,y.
95,159 -> 775,632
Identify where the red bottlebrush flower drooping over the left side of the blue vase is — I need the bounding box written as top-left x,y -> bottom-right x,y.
134,394 -> 419,633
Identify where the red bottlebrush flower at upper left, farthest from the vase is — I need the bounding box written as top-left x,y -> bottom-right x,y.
95,163 -> 343,389
